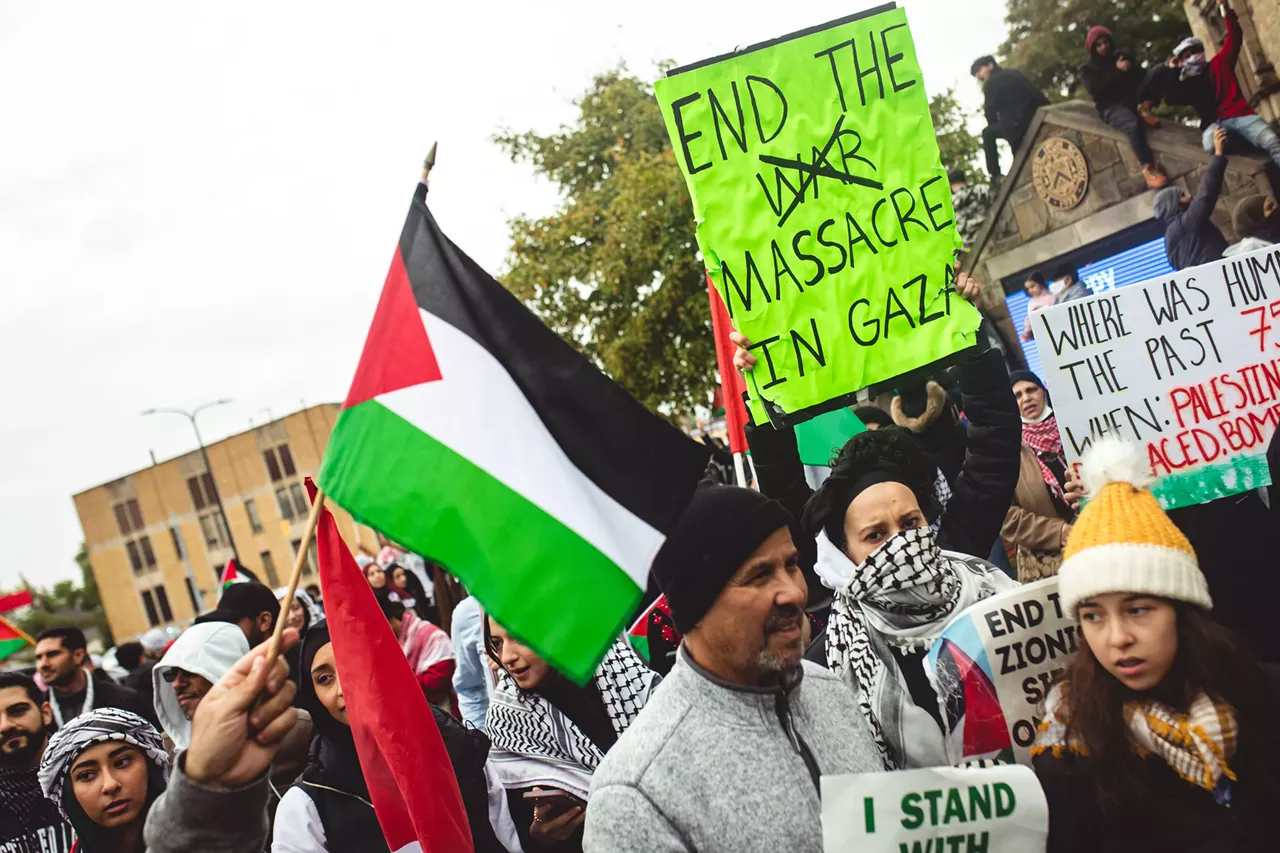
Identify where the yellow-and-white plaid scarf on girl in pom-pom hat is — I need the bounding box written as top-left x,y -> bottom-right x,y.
1032,684 -> 1239,792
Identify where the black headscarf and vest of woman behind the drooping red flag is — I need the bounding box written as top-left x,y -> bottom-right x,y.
298,621 -> 506,853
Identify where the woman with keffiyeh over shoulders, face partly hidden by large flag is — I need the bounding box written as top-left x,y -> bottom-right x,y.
484,616 -> 662,853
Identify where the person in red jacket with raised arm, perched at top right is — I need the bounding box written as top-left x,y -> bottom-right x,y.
1151,3 -> 1280,165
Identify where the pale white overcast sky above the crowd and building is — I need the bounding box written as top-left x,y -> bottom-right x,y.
0,0 -> 1005,589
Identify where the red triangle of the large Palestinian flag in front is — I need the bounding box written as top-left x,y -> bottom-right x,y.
342,246 -> 442,409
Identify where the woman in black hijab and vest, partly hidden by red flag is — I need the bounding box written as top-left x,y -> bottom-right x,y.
271,622 -> 509,853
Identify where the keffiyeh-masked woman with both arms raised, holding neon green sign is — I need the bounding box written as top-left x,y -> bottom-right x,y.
735,273 -> 1021,770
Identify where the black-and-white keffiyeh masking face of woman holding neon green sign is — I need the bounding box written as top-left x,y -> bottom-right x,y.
819,528 -> 1015,770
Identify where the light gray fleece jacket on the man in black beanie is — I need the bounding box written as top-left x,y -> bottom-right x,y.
582,647 -> 884,853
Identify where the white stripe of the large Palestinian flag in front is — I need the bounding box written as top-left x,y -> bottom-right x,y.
378,309 -> 663,589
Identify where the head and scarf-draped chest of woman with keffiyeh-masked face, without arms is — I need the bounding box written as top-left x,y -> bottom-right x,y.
803,429 -> 1015,768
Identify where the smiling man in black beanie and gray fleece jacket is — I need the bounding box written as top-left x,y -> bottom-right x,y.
582,484 -> 883,853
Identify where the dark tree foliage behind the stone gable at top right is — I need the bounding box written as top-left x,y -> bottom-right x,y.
998,0 -> 1190,101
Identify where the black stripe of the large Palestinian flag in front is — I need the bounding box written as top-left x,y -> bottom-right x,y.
399,184 -> 708,533
